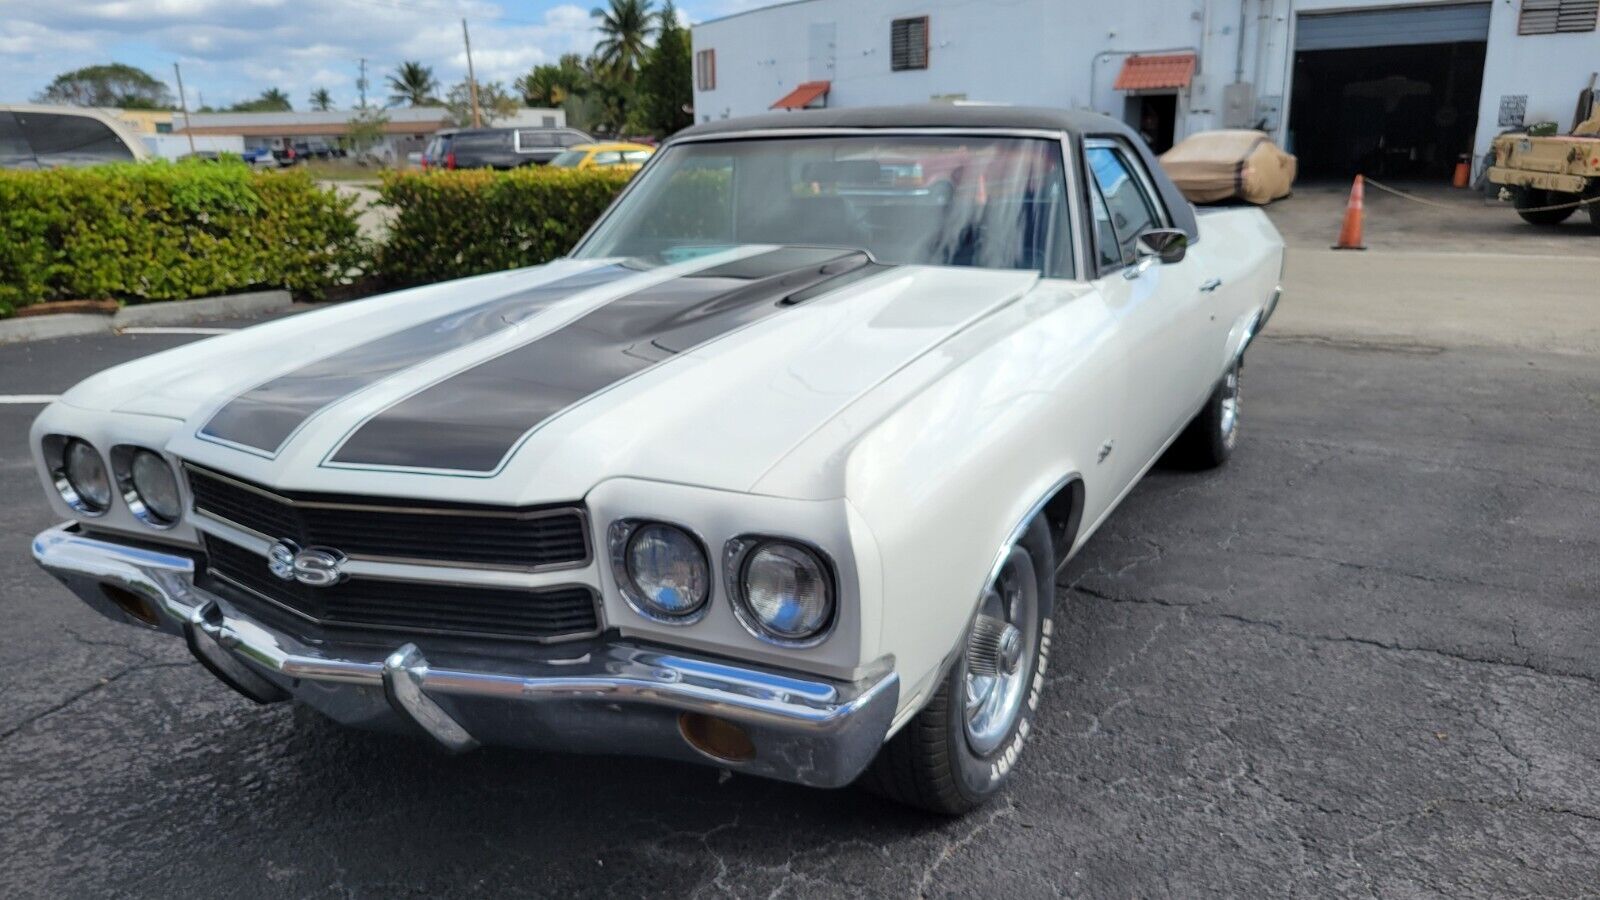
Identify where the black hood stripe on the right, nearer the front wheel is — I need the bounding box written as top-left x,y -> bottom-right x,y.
330,248 -> 877,474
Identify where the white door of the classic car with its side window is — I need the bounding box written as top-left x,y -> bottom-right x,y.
1083,138 -> 1216,479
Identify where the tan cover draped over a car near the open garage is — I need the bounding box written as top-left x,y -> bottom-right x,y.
1162,130 -> 1294,203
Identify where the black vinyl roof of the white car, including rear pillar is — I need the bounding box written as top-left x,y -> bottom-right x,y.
674,102 -> 1200,240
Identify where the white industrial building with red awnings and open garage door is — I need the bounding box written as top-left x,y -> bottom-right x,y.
693,0 -> 1600,176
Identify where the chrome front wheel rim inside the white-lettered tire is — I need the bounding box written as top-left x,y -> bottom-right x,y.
962,546 -> 1038,756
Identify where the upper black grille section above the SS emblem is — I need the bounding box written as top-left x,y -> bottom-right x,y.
187,466 -> 589,569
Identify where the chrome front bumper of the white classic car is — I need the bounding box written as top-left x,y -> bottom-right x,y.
34,524 -> 899,788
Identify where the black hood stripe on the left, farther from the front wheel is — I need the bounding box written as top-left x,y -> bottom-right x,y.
200,266 -> 638,458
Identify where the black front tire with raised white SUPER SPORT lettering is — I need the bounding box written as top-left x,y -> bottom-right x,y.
858,516 -> 1056,815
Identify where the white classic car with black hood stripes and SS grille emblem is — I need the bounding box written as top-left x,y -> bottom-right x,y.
32,106 -> 1283,814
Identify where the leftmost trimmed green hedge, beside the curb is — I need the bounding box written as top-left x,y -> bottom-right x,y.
0,162 -> 371,317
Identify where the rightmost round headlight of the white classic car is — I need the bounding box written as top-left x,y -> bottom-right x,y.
739,541 -> 834,644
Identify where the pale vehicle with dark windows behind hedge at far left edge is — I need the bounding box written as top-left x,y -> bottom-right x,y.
0,106 -> 154,168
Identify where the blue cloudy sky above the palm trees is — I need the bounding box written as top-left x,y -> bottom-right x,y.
0,0 -> 773,109
